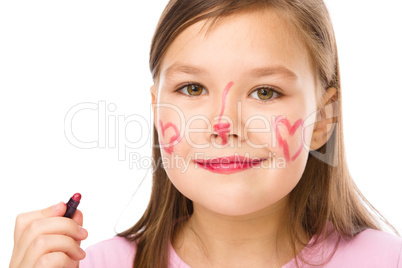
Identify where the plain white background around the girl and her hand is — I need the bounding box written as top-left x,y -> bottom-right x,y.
0,0 -> 402,267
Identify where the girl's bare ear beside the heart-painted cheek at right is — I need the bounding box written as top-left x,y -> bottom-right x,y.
310,87 -> 338,151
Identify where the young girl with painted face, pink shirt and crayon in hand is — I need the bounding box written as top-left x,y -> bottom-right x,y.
10,0 -> 402,268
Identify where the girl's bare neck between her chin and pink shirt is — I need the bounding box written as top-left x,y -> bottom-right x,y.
172,198 -> 308,267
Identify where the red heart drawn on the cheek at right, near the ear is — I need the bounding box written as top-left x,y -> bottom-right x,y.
275,117 -> 305,161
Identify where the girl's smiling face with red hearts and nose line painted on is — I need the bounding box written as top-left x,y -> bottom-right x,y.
151,11 -> 317,215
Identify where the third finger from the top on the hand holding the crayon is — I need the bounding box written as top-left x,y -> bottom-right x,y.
22,235 -> 85,264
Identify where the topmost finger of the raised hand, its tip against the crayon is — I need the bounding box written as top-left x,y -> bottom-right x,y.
14,202 -> 67,244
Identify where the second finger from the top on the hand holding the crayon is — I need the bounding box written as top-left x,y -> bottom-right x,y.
15,217 -> 88,259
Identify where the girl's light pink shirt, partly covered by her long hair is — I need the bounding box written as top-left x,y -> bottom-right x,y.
80,229 -> 402,268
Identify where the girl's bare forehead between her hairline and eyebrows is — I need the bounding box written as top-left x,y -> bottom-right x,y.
160,10 -> 312,86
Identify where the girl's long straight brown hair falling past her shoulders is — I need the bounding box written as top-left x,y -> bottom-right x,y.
119,0 -> 396,267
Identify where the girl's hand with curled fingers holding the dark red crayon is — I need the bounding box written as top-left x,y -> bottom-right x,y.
10,202 -> 88,268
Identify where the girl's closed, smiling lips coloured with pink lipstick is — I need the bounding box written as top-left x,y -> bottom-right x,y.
194,155 -> 266,174
